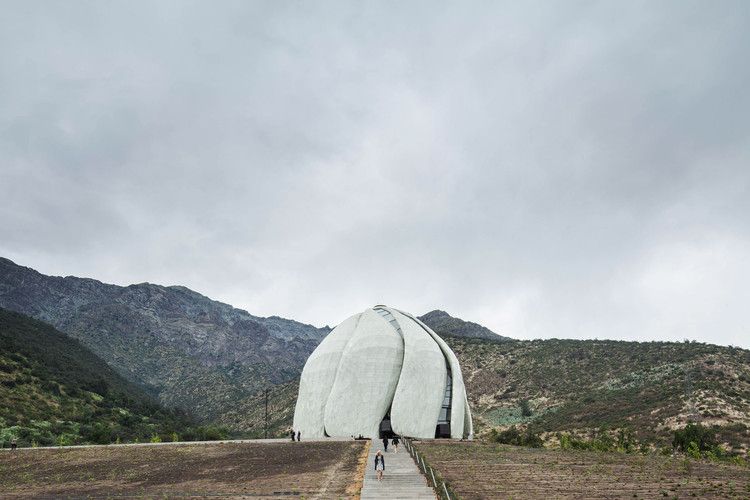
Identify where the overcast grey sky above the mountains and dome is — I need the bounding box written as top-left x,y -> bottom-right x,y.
0,0 -> 750,347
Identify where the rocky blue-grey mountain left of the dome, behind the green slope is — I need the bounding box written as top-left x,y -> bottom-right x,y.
0,258 -> 330,422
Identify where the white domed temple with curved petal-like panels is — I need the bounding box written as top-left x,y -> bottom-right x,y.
294,305 -> 473,439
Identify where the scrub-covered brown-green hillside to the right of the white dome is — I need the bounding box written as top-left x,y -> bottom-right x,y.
446,337 -> 750,452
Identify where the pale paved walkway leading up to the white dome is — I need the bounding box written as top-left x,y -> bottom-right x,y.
361,439 -> 435,500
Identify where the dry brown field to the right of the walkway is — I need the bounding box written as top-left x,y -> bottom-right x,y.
416,441 -> 750,500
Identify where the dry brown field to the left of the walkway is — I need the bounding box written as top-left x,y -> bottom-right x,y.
0,442 -> 365,498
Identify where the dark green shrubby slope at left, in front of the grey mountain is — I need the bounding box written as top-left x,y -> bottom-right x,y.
0,309 -> 194,446
